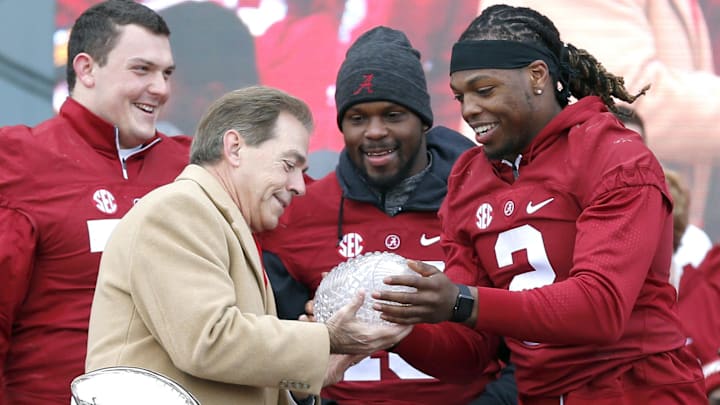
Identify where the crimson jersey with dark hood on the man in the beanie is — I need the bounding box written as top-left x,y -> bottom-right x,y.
260,127 -> 499,405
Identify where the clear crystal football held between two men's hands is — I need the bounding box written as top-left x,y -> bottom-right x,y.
313,252 -> 419,325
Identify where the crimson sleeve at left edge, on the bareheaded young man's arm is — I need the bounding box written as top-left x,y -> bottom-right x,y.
0,205 -> 36,398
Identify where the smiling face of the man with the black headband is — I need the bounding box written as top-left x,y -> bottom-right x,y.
450,65 -> 553,161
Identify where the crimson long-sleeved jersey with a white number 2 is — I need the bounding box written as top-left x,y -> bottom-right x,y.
416,97 -> 699,398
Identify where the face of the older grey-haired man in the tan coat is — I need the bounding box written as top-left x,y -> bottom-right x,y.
233,112 -> 310,232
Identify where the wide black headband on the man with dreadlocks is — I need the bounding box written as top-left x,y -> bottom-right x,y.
450,40 -> 560,74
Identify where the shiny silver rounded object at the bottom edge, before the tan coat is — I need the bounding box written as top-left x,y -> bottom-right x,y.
70,366 -> 200,405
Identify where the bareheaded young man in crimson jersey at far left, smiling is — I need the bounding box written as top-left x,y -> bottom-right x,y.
0,0 -> 190,405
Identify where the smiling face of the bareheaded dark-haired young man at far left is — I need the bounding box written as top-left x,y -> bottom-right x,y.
73,25 -> 174,148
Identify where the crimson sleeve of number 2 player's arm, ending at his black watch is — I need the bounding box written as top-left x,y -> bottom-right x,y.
470,186 -> 672,344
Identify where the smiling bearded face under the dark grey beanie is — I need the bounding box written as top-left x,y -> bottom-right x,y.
341,101 -> 427,188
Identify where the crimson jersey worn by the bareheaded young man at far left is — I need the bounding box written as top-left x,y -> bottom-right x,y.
0,98 -> 190,405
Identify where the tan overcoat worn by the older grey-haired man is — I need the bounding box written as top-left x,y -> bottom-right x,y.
86,165 -> 329,405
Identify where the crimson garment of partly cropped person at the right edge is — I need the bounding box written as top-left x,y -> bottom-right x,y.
678,245 -> 720,393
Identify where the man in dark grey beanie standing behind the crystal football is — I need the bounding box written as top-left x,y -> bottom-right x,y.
259,27 -> 516,405
